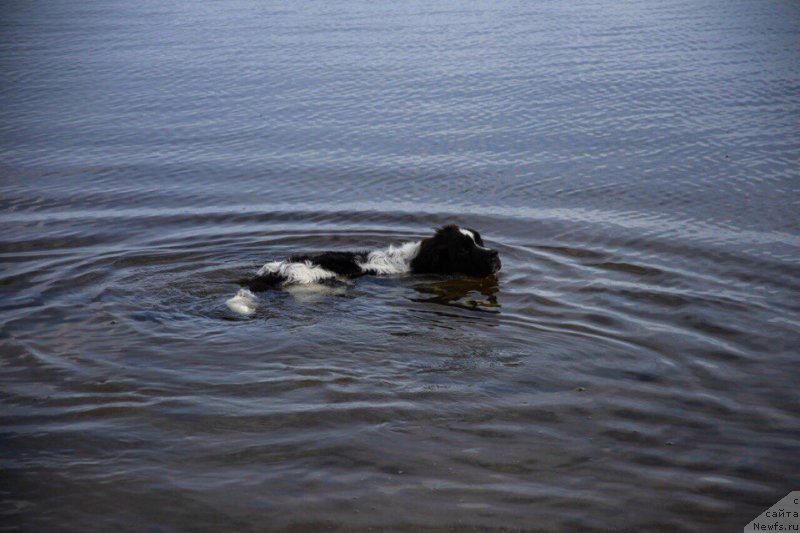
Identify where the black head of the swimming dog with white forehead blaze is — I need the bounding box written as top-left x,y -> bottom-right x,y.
411,224 -> 500,277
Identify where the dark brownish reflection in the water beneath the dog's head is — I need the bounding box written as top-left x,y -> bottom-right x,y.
411,276 -> 501,313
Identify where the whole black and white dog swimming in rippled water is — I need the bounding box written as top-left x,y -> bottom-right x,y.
226,224 -> 500,315
